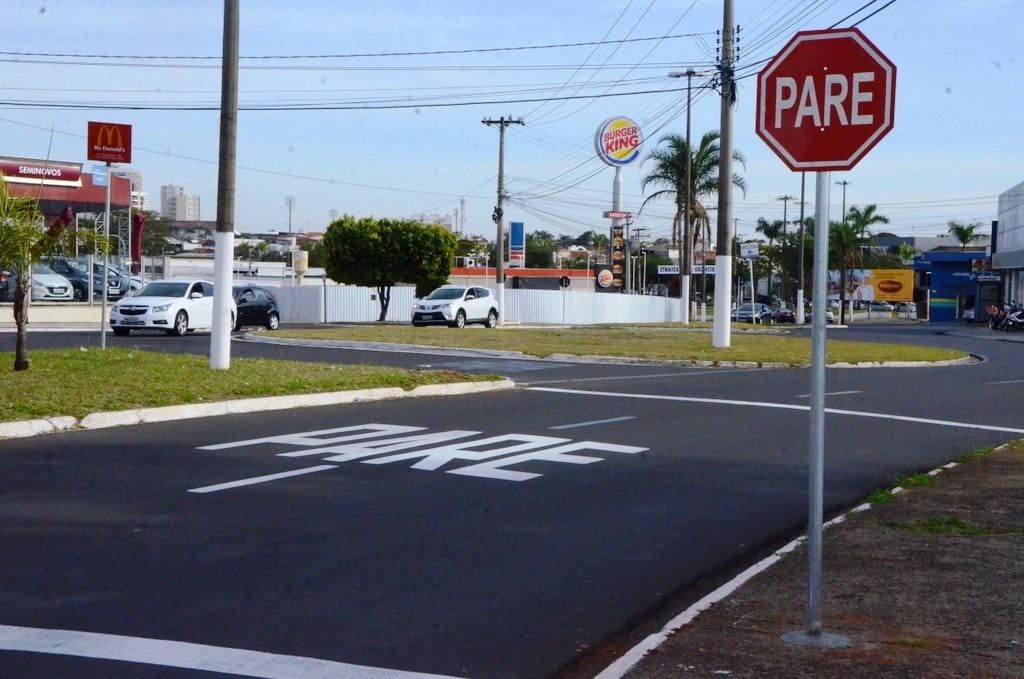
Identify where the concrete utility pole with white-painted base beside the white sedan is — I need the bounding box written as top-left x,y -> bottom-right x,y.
210,0 -> 239,370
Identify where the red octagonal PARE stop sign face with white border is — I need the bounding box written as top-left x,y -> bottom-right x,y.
757,29 -> 896,172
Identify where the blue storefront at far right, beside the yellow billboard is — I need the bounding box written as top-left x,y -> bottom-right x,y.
913,250 -> 1001,323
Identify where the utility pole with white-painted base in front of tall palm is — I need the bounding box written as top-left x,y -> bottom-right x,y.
712,0 -> 735,349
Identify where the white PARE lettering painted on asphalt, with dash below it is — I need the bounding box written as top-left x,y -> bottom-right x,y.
189,423 -> 647,493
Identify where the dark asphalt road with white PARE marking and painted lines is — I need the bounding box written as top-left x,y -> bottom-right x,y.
0,326 -> 1024,679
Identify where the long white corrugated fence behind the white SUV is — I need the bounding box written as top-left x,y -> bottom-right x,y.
274,284 -> 682,326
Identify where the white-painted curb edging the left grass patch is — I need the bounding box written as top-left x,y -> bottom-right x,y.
0,380 -> 515,439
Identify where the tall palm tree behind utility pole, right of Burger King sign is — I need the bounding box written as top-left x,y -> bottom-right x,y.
640,130 -> 746,271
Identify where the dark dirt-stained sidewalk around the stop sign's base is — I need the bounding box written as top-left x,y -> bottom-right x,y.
589,441 -> 1024,679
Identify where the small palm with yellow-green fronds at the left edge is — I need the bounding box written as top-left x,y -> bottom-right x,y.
0,181 -> 110,371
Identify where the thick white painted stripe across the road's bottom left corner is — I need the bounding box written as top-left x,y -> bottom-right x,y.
0,625 -> 454,679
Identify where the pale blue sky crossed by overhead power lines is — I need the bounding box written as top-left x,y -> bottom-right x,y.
0,0 -> 1024,240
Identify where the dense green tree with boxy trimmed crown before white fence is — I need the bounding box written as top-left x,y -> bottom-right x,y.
324,215 -> 457,323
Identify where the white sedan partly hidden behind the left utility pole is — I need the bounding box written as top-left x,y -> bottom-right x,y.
111,279 -> 238,337
